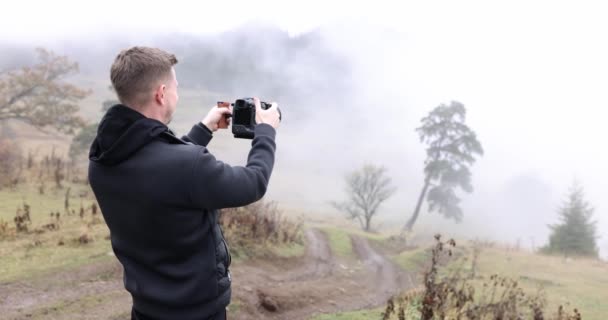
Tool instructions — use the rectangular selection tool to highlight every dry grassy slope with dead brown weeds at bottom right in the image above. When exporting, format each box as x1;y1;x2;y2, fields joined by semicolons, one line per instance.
383;235;608;320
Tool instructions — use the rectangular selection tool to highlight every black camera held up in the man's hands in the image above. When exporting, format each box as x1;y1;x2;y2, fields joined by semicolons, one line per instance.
218;98;281;139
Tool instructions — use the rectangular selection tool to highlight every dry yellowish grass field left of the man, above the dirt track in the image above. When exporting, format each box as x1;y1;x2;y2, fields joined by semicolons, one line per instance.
0;184;114;282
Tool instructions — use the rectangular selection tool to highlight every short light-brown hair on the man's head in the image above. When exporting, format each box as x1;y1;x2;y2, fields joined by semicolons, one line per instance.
110;47;177;105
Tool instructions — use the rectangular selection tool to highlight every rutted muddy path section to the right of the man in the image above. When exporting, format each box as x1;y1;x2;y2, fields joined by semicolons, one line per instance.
233;230;414;320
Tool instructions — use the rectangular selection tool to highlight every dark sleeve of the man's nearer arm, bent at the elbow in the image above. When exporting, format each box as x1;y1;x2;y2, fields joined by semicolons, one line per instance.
190;124;276;209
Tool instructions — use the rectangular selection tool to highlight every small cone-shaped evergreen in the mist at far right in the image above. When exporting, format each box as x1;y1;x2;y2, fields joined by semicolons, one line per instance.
543;183;598;257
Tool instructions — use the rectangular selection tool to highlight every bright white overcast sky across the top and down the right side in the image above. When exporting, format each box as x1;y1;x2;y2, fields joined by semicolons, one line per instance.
0;0;608;255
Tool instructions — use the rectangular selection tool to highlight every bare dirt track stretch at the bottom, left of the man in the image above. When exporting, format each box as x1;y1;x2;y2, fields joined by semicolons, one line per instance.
0;260;131;320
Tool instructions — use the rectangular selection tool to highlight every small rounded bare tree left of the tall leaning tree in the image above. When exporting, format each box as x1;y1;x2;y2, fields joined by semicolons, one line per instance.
332;165;396;231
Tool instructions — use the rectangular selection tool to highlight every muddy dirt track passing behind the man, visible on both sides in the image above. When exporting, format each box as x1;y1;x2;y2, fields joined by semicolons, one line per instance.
0;229;413;320
